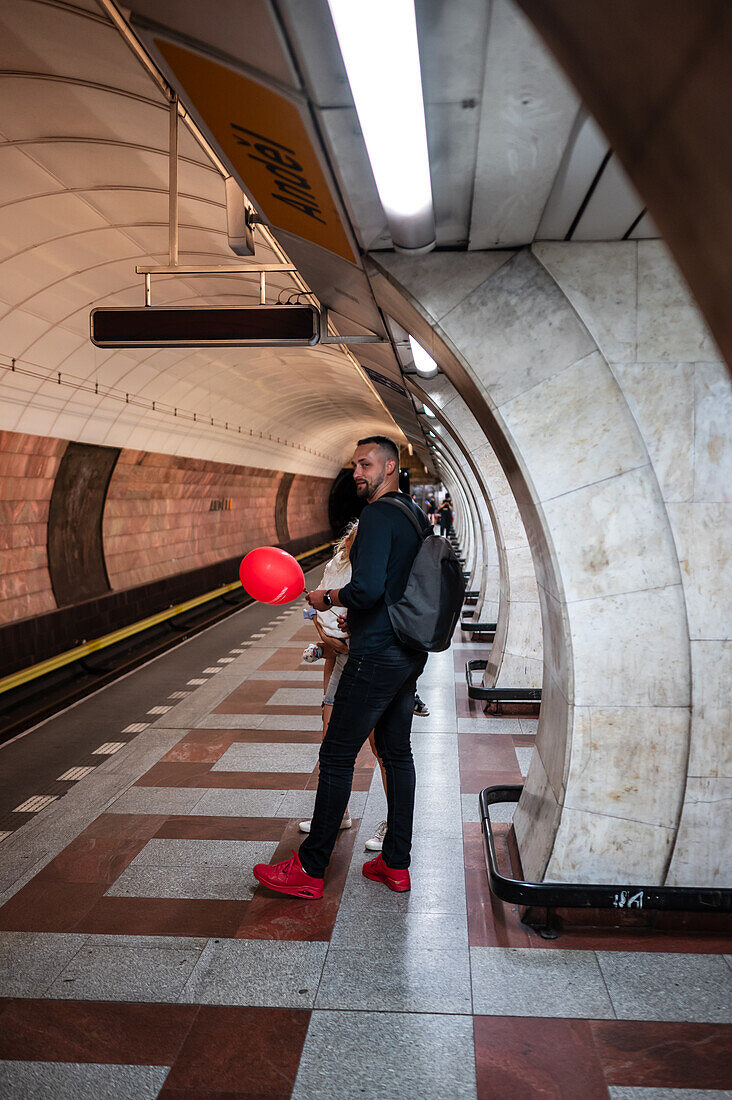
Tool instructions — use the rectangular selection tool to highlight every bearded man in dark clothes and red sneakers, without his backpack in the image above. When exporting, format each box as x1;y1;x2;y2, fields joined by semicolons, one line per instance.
254;436;430;898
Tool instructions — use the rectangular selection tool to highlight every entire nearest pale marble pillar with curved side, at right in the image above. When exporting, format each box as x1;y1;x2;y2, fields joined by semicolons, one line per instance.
372;241;732;886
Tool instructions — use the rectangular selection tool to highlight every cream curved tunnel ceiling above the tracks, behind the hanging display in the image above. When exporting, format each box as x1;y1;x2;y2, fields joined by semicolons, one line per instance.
0;0;405;474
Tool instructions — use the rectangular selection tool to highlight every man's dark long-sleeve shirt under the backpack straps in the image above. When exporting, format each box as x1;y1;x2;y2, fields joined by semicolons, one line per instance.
340;493;431;656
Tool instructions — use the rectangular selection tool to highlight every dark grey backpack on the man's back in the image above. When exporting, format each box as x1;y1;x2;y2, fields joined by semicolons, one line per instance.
382;496;466;653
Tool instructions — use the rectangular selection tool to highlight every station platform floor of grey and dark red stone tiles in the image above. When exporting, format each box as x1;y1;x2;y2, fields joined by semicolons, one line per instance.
0;589;732;1100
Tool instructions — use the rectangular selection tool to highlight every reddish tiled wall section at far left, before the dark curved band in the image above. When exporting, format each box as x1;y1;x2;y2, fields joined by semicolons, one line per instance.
0;431;66;623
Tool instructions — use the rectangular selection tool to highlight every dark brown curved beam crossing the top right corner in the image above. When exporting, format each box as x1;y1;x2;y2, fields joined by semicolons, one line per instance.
517;0;732;367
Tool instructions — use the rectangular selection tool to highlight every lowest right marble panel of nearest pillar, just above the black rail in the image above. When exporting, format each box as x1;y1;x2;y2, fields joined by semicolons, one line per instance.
666;777;732;890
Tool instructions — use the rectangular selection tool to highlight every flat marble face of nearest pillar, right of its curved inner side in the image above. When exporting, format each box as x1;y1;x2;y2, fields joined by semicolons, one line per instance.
535;234;732;884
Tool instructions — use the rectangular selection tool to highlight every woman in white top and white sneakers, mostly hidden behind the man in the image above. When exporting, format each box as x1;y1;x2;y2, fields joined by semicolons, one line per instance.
299;519;386;851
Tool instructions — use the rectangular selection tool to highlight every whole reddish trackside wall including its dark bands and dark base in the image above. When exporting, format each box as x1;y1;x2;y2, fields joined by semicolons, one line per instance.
0;431;331;673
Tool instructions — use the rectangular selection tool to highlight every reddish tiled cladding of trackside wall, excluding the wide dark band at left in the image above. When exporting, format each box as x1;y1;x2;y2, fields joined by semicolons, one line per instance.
0;431;330;629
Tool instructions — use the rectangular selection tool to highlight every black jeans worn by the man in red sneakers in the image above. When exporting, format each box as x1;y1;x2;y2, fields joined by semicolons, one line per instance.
299;646;427;878
